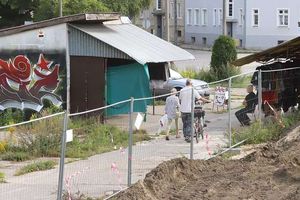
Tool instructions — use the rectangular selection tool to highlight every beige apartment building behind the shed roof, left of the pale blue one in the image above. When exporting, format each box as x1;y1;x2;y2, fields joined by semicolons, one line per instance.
133;0;185;44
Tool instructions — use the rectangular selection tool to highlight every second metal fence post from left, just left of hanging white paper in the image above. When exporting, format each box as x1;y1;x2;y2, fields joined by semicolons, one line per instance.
127;97;134;187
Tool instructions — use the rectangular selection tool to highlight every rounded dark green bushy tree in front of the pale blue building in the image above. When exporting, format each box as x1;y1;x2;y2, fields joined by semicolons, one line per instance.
210;35;238;80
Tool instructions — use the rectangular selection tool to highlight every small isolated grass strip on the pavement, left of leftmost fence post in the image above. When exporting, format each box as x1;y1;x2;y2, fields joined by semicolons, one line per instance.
15;160;57;176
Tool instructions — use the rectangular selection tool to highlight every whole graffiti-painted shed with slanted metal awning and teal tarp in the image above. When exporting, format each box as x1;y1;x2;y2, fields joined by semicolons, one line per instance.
0;13;194;113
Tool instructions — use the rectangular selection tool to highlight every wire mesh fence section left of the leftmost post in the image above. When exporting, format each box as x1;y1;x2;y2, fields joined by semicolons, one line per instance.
0;112;63;200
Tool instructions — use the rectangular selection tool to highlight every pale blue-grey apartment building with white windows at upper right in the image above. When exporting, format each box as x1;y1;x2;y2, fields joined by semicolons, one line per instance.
185;0;300;49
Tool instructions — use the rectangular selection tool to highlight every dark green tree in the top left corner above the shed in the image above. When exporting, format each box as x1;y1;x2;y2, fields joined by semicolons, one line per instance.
0;0;39;28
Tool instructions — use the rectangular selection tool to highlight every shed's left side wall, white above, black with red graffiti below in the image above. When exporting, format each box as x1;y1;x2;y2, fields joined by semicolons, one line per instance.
0;25;67;112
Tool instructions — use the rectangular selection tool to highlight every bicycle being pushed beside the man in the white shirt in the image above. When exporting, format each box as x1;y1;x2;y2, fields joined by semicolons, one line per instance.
194;104;205;143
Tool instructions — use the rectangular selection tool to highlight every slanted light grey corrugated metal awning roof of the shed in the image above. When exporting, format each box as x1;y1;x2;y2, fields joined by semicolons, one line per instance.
73;24;195;64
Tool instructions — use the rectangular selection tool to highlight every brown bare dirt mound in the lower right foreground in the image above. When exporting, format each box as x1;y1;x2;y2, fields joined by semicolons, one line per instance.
115;129;300;200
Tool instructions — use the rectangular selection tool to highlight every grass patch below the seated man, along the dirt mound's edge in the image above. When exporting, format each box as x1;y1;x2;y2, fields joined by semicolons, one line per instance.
232;111;300;144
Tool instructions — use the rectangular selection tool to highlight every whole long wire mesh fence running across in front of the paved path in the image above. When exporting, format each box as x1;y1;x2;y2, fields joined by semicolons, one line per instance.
0;68;300;199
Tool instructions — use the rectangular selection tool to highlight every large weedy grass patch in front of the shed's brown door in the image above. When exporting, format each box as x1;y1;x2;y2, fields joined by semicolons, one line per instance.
66;119;150;158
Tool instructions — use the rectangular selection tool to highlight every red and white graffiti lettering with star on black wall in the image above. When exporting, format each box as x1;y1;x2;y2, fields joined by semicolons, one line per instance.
0;54;62;111
